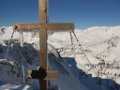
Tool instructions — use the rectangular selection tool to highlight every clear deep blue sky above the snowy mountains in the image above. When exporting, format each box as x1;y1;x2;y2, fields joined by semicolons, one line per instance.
0;0;120;28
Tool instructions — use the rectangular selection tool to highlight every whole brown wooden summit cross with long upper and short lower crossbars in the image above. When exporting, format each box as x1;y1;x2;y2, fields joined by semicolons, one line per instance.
13;0;74;90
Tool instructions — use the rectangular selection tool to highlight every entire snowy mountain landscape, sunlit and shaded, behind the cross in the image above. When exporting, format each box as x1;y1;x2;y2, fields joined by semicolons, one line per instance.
0;26;120;90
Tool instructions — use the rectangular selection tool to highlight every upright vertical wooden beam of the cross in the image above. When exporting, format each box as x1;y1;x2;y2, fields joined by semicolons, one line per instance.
39;0;48;90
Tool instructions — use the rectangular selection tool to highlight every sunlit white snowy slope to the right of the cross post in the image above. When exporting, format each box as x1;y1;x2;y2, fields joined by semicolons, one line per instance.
49;26;120;83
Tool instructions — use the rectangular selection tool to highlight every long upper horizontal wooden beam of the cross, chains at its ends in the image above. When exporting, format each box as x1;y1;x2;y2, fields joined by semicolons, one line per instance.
13;23;74;31
